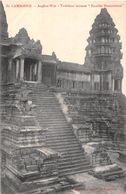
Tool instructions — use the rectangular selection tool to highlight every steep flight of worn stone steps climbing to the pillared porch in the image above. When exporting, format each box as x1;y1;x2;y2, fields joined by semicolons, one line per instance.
24;83;91;177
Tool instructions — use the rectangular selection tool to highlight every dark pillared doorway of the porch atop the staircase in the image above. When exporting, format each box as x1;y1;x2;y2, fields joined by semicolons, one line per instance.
24;58;38;81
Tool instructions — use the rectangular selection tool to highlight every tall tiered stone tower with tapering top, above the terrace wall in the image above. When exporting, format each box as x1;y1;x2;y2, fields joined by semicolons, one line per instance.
85;8;123;92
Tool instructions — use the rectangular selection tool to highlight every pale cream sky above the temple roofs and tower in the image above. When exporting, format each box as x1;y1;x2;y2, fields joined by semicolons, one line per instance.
3;0;126;94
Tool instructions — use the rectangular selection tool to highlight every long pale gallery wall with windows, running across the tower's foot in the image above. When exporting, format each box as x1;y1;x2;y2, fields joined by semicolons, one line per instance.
56;69;122;93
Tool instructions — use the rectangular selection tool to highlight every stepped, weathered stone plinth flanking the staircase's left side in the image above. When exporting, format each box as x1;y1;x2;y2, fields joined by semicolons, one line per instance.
2;83;58;185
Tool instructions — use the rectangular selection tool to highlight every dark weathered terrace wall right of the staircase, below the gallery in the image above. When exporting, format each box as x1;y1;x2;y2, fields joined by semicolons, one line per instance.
61;92;124;144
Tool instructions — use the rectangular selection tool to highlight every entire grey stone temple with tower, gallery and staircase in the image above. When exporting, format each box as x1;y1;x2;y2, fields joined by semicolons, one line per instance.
0;2;126;194
